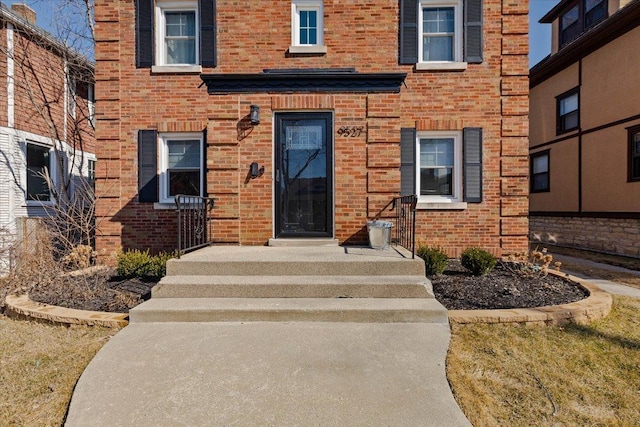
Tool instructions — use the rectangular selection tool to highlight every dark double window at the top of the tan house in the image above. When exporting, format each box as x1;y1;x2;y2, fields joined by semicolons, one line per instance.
560;0;607;47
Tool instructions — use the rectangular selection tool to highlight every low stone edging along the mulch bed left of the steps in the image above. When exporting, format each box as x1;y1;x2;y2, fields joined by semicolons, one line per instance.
5;294;129;328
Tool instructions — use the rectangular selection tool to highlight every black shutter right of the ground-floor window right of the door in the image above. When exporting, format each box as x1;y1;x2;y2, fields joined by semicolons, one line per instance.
462;128;482;203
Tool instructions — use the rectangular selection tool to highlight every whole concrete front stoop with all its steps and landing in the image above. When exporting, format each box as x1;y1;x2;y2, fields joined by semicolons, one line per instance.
130;245;448;324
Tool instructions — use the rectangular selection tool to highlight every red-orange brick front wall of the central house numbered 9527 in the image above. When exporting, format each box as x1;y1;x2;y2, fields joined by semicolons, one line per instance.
96;0;528;255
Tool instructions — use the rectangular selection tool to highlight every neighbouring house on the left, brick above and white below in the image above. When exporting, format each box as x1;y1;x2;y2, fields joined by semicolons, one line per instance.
0;4;96;268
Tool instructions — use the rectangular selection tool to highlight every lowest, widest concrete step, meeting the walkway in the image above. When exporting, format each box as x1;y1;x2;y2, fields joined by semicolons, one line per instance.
129;298;448;323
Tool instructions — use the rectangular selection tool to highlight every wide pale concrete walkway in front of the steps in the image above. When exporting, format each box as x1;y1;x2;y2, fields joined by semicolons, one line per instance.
66;322;470;427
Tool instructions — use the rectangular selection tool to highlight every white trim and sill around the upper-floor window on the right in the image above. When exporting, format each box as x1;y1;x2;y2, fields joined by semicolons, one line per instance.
416;0;467;70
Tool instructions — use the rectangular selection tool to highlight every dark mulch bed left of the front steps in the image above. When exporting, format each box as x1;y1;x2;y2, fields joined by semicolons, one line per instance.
29;268;157;313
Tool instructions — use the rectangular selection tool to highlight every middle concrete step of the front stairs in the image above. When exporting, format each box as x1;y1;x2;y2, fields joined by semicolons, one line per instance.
151;276;434;298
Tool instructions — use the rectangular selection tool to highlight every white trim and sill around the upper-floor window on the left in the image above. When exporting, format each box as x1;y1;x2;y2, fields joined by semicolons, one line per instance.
151;1;201;67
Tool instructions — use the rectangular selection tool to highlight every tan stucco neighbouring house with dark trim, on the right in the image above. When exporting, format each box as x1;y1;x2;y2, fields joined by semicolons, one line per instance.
530;0;640;257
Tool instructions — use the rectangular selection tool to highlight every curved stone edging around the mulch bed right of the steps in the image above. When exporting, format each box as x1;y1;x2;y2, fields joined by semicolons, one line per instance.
449;271;612;324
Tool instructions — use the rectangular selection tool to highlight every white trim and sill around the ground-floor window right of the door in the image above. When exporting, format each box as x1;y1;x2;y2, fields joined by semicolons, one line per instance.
415;131;467;209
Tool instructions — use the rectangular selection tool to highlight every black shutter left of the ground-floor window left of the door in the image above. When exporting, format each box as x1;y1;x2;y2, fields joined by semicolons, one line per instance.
138;130;158;202
